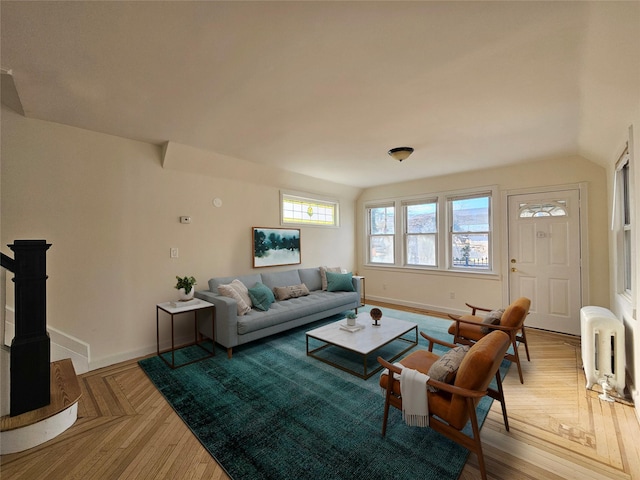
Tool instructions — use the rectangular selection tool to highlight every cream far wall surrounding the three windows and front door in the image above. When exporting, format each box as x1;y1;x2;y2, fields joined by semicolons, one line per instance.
357;157;609;312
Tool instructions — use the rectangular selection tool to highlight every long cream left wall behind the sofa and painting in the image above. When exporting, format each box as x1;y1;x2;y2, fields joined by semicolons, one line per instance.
0;108;359;369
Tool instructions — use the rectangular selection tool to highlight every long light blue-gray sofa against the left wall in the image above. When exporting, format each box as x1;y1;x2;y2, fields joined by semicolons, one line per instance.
195;268;361;358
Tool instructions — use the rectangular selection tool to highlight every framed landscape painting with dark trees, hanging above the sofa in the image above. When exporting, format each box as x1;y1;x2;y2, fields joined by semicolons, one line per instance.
252;227;302;268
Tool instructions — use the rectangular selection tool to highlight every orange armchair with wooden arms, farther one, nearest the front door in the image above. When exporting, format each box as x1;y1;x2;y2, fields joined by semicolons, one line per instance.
449;297;531;383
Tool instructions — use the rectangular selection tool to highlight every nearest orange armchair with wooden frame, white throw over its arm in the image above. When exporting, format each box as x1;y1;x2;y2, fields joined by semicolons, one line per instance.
378;331;510;480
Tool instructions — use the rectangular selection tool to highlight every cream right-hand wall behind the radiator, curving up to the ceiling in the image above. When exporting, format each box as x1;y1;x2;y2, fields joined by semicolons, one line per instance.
578;2;640;418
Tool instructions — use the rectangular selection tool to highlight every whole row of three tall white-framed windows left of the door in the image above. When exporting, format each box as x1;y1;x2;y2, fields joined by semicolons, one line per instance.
365;187;495;274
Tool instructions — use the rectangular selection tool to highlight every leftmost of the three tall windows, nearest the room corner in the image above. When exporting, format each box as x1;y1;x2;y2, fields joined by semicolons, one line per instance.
367;204;396;265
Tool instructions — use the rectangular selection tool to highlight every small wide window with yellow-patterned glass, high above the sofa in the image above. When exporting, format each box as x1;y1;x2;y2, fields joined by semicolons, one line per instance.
280;192;339;227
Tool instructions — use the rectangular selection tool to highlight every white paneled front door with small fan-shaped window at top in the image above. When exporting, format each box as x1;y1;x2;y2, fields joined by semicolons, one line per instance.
508;190;582;335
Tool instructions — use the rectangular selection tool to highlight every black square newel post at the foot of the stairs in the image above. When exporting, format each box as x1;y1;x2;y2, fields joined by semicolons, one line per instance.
8;240;51;417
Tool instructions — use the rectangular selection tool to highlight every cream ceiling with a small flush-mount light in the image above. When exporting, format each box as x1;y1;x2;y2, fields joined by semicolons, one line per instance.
0;0;640;187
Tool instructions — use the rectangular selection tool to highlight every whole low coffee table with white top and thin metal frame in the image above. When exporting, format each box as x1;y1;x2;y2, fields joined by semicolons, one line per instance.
306;313;418;380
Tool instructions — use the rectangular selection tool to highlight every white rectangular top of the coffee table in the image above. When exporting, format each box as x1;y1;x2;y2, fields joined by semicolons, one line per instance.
306;312;418;355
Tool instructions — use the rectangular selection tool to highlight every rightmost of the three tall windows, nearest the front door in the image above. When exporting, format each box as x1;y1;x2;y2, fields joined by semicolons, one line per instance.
448;194;491;270
